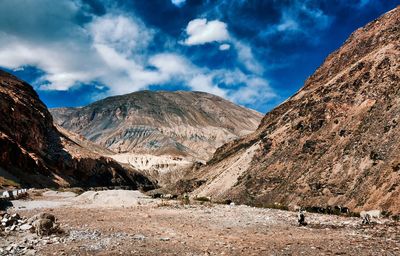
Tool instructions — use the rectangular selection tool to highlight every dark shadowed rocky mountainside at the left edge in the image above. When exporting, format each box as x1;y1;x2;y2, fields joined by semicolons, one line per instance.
0;70;154;189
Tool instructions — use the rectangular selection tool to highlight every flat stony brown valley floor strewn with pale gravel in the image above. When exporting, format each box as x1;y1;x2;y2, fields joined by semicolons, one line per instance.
0;191;400;255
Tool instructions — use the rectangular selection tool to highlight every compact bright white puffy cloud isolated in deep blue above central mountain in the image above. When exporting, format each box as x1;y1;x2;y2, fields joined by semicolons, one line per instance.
184;19;229;45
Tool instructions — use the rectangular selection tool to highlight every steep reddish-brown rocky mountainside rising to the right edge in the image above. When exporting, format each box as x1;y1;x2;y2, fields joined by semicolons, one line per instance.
184;7;400;213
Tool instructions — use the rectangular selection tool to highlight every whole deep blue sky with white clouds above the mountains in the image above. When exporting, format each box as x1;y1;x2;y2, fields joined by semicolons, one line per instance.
0;0;400;113
